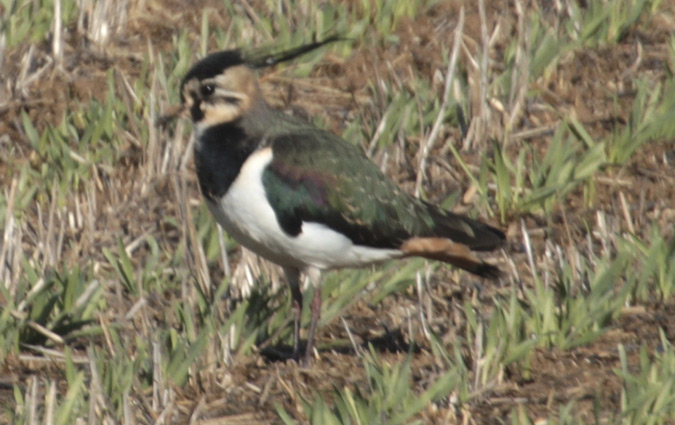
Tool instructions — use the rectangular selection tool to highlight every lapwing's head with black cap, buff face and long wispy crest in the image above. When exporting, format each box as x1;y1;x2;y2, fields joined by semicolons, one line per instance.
181;37;338;127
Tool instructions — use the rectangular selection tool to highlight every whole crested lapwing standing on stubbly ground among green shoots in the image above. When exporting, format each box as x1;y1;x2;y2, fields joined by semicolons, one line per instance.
181;40;505;365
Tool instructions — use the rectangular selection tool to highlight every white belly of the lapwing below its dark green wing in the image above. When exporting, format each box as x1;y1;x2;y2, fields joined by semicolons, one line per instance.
208;148;402;269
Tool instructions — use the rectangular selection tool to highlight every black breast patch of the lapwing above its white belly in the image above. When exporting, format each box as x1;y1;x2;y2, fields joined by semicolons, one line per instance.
194;123;257;201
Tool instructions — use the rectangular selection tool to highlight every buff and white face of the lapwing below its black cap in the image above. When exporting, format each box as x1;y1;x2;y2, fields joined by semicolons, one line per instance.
183;65;260;128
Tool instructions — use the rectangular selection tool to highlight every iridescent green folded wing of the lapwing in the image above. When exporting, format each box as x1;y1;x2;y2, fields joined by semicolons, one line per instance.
263;128;503;249
